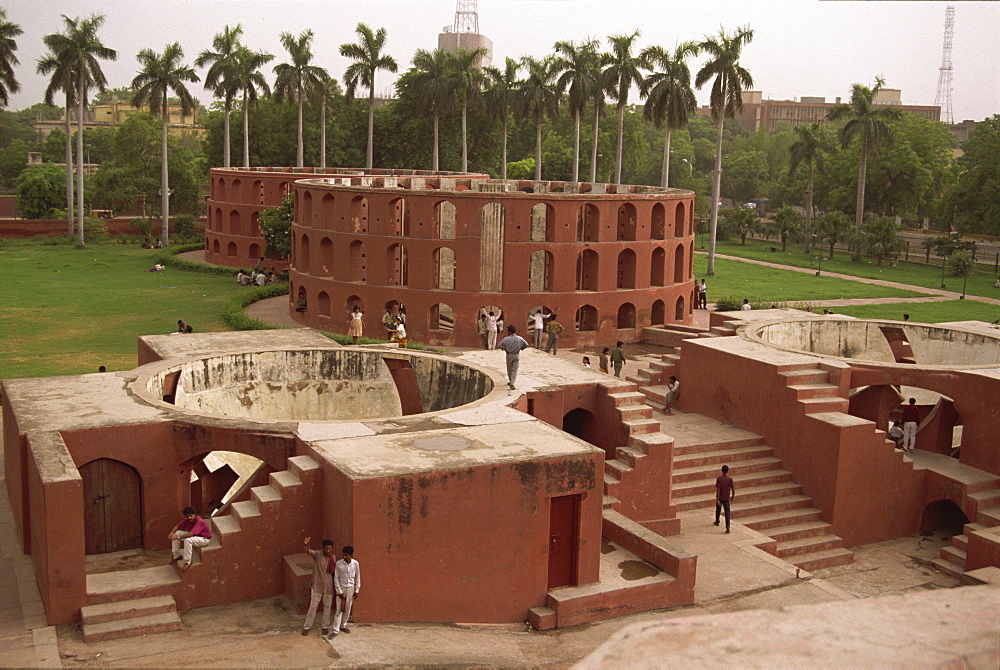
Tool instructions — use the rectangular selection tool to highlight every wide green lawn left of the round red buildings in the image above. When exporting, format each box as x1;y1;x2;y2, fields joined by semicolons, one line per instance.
0;243;240;379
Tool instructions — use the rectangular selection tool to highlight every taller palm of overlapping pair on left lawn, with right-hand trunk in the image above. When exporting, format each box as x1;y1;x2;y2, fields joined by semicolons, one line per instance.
39;14;118;247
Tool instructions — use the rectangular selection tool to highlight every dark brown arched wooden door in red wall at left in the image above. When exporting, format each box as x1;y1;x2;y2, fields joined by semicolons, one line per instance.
80;458;142;554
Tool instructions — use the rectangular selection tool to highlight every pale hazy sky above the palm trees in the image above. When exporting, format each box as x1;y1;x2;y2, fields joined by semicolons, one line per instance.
7;0;1000;121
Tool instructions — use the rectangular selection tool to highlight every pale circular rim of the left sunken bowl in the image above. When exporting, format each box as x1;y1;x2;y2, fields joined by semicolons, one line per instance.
128;345;510;427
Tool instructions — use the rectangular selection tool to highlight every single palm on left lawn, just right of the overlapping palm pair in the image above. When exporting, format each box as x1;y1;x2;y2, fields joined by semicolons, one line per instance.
132;42;198;246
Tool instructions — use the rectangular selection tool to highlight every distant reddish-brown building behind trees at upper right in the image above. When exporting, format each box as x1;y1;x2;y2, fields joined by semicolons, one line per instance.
698;88;941;132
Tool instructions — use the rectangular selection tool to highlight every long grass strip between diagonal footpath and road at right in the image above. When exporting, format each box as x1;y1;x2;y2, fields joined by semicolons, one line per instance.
695;236;1000;298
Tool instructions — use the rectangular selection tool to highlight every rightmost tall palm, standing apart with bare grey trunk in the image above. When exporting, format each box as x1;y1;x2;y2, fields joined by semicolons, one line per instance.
826;77;902;236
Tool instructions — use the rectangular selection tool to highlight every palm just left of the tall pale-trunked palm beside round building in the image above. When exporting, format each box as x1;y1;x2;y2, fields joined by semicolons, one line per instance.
640;42;698;188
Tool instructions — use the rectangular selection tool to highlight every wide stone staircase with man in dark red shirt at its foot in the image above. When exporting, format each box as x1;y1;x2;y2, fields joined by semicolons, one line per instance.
672;437;854;571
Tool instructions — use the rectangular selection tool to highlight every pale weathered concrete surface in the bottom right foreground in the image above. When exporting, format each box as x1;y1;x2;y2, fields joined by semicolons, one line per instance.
575;586;1000;668
